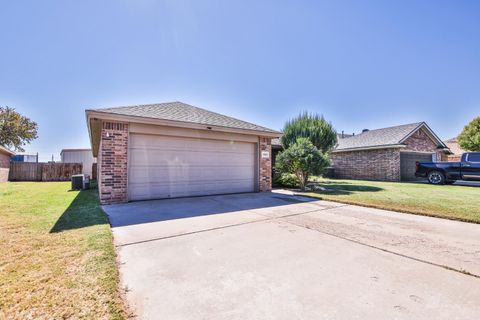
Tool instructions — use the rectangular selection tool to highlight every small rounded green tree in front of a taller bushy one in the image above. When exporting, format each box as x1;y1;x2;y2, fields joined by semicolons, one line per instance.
275;137;330;191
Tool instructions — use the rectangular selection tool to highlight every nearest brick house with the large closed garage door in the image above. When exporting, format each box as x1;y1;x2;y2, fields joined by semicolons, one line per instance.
86;102;280;204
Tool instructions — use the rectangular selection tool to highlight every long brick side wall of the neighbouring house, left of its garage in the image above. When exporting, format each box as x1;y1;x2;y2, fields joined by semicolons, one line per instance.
330;148;400;181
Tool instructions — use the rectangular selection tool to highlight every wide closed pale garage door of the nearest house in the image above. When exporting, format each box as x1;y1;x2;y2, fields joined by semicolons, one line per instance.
128;134;256;200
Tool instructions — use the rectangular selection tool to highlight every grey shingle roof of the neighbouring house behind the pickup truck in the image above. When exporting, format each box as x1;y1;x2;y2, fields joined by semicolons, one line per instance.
334;122;446;152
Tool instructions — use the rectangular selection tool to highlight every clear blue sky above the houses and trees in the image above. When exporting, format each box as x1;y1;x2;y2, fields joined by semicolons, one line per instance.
0;0;480;160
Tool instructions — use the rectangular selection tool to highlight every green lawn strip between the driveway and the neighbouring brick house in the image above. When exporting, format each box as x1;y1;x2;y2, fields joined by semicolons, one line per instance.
307;179;480;223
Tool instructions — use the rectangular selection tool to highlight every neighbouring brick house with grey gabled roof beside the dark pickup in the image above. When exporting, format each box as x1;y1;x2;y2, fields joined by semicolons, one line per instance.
330;122;451;181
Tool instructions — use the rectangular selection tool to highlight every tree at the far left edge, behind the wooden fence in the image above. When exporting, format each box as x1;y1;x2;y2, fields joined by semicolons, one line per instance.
0;107;38;151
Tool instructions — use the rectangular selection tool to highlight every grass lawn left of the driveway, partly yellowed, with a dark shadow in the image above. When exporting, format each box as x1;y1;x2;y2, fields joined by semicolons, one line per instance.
0;182;127;319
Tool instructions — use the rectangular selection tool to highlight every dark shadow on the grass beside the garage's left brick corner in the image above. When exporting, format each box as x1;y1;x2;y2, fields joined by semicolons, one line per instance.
50;189;108;233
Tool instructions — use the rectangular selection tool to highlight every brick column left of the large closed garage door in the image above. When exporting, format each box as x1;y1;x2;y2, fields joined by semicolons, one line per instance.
98;121;128;204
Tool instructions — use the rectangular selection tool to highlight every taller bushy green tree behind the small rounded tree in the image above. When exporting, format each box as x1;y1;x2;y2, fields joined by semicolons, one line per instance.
281;112;337;152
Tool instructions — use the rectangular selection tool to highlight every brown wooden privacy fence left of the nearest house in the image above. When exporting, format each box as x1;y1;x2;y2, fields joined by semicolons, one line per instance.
8;161;83;181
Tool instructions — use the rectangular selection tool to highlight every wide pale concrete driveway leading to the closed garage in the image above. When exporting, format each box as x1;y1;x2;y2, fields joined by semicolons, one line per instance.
104;193;480;320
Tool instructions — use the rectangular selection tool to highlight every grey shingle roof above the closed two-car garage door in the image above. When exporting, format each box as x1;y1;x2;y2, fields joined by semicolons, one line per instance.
87;101;279;133
